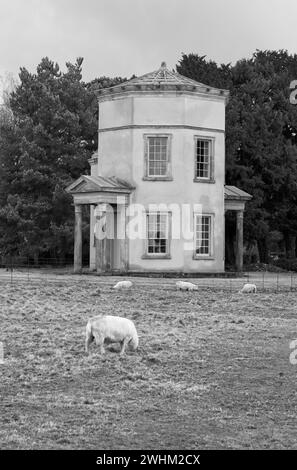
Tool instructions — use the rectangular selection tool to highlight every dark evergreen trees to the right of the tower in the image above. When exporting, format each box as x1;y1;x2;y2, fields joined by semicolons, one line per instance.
177;51;297;262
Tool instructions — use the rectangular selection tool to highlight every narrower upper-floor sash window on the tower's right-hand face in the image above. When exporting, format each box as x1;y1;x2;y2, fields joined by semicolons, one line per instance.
195;137;214;181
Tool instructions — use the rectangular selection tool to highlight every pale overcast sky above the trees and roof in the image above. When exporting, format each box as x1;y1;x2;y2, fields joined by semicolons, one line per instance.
0;0;297;81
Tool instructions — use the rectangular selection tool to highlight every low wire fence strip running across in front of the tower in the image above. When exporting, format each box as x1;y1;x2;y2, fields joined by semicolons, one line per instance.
0;258;297;293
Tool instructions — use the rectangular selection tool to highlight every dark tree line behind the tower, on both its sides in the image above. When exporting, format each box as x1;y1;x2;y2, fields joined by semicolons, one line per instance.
0;50;297;262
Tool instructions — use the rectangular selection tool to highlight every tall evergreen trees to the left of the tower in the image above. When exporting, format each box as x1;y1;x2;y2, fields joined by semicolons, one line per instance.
0;58;125;259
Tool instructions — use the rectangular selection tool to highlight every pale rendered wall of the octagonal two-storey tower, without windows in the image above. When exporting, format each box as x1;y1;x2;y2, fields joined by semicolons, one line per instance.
98;94;225;272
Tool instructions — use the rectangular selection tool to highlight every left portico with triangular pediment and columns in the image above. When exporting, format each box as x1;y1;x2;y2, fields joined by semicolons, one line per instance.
67;175;134;273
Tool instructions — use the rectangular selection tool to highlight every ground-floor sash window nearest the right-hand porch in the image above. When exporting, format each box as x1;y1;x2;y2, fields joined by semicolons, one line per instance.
194;214;213;258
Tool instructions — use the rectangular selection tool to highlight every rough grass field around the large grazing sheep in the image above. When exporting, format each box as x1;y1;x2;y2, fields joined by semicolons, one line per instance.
0;277;297;450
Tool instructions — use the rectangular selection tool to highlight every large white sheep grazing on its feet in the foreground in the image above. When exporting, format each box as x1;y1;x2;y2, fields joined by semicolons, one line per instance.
86;315;138;356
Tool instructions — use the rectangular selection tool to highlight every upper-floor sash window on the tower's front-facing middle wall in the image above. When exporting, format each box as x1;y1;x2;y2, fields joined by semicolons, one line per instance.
144;134;172;180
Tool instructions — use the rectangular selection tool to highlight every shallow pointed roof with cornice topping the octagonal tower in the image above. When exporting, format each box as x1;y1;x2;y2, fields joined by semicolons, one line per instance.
97;62;229;97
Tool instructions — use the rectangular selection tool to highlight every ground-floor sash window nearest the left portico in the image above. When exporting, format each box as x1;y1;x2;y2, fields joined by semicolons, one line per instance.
146;212;169;256
